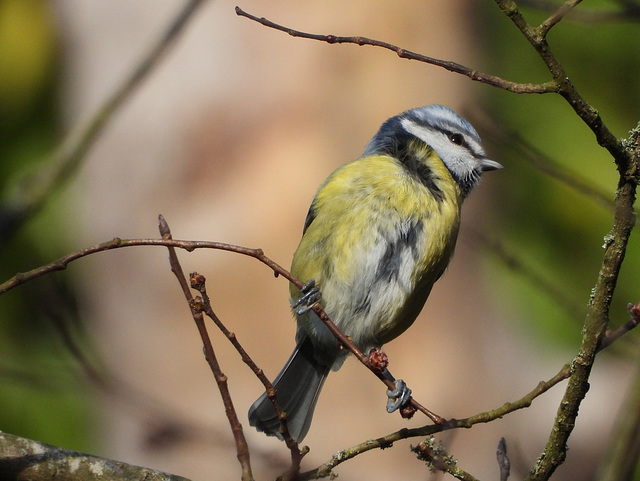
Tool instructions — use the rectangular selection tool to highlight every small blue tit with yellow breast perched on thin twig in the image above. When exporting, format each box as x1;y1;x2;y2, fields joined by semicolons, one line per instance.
249;105;502;442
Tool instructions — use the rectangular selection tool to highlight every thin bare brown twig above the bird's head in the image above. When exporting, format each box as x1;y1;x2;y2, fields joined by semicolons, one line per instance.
236;7;558;94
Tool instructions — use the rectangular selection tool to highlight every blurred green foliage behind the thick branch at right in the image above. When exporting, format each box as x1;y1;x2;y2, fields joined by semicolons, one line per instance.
479;2;640;347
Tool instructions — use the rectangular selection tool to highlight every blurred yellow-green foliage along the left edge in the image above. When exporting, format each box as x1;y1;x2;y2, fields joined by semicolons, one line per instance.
0;0;88;449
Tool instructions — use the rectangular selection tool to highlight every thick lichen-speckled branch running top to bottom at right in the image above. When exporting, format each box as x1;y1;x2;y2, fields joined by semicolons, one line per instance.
482;0;640;480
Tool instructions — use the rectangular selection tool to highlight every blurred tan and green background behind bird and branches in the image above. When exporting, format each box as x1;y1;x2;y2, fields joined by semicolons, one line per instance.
0;0;640;480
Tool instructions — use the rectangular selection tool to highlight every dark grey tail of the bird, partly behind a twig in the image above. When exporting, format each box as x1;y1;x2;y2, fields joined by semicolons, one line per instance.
249;337;330;442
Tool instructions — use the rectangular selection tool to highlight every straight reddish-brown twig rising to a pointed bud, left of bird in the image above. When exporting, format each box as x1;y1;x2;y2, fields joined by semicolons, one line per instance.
158;215;253;481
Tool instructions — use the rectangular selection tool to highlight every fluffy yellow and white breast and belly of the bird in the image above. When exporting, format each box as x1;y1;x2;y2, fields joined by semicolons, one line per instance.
292;157;460;349
